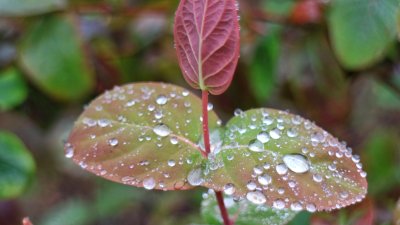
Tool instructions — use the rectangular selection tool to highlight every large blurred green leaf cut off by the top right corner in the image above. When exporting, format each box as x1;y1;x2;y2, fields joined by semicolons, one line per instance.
328;0;400;69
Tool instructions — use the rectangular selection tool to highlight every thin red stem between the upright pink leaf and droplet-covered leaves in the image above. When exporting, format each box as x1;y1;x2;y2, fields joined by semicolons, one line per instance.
201;90;233;225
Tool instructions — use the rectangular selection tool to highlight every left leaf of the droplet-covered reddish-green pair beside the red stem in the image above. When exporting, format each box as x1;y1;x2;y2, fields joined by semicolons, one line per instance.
66;83;218;190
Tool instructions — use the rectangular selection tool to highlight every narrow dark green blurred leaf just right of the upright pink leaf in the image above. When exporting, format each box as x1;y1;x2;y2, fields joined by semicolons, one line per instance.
249;27;280;103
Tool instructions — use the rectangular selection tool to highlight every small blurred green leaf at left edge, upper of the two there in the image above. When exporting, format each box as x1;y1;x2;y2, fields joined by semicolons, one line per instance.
0;68;27;111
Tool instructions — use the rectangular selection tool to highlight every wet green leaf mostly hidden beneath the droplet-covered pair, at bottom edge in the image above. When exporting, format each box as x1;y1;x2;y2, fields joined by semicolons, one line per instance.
201;191;296;225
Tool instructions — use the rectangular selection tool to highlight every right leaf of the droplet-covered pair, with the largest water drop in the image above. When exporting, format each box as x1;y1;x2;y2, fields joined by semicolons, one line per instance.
203;109;367;212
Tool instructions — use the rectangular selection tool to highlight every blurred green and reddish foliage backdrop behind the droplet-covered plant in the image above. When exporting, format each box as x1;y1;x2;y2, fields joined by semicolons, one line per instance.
0;0;400;225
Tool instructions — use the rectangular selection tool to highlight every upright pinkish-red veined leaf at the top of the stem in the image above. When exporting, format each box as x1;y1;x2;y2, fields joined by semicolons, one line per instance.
174;0;240;95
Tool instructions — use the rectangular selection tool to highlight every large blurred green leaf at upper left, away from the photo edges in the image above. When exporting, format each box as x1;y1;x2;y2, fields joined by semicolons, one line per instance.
19;15;94;101
